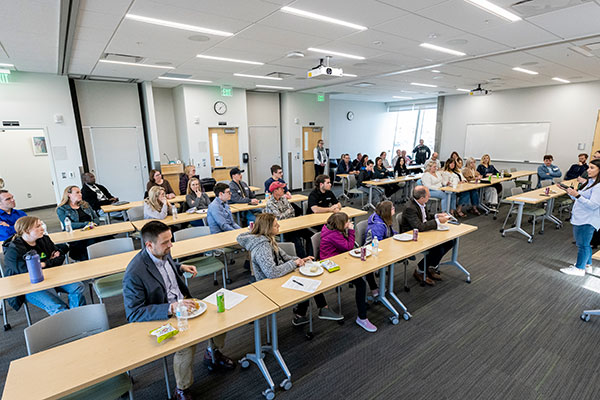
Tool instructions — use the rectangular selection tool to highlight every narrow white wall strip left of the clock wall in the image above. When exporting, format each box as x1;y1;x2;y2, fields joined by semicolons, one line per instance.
152;88;183;163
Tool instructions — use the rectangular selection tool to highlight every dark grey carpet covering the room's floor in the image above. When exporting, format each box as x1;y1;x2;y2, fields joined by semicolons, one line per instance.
0;195;600;399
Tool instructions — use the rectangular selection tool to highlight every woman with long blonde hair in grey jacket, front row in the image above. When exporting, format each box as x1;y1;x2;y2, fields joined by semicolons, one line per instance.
237;213;344;326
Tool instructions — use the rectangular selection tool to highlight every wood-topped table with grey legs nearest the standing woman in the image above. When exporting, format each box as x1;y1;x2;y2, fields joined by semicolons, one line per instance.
501;179;577;243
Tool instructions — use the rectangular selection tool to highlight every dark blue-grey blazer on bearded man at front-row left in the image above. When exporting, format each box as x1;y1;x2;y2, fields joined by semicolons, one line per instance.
123;248;192;322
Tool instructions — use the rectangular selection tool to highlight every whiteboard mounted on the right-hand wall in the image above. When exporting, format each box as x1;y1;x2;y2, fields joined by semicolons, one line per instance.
465;122;550;162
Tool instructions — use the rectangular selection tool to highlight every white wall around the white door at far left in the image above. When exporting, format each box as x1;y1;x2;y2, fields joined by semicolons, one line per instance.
0;72;81;207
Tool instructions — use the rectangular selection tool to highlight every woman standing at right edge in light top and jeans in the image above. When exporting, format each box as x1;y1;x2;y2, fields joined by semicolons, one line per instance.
560;160;600;276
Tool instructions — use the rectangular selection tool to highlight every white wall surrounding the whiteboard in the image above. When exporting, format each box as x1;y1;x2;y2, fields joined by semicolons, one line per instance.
440;82;600;174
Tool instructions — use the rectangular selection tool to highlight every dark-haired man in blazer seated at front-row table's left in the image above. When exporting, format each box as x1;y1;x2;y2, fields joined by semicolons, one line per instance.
123;221;235;399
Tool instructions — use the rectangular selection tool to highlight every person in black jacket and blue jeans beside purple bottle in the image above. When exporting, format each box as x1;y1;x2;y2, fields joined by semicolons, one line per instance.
2;217;85;315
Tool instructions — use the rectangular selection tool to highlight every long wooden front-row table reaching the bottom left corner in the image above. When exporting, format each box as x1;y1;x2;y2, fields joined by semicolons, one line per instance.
2;285;286;400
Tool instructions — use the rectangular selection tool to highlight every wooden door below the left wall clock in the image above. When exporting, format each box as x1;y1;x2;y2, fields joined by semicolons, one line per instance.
208;128;240;182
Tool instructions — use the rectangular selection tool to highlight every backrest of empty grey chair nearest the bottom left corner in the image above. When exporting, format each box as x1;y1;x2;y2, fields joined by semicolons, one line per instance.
25;304;109;355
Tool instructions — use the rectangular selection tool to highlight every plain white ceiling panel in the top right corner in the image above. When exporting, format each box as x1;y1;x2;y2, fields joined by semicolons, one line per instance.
528;2;600;39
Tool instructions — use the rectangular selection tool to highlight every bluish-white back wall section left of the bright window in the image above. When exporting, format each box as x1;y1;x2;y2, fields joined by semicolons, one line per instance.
329;100;396;162
